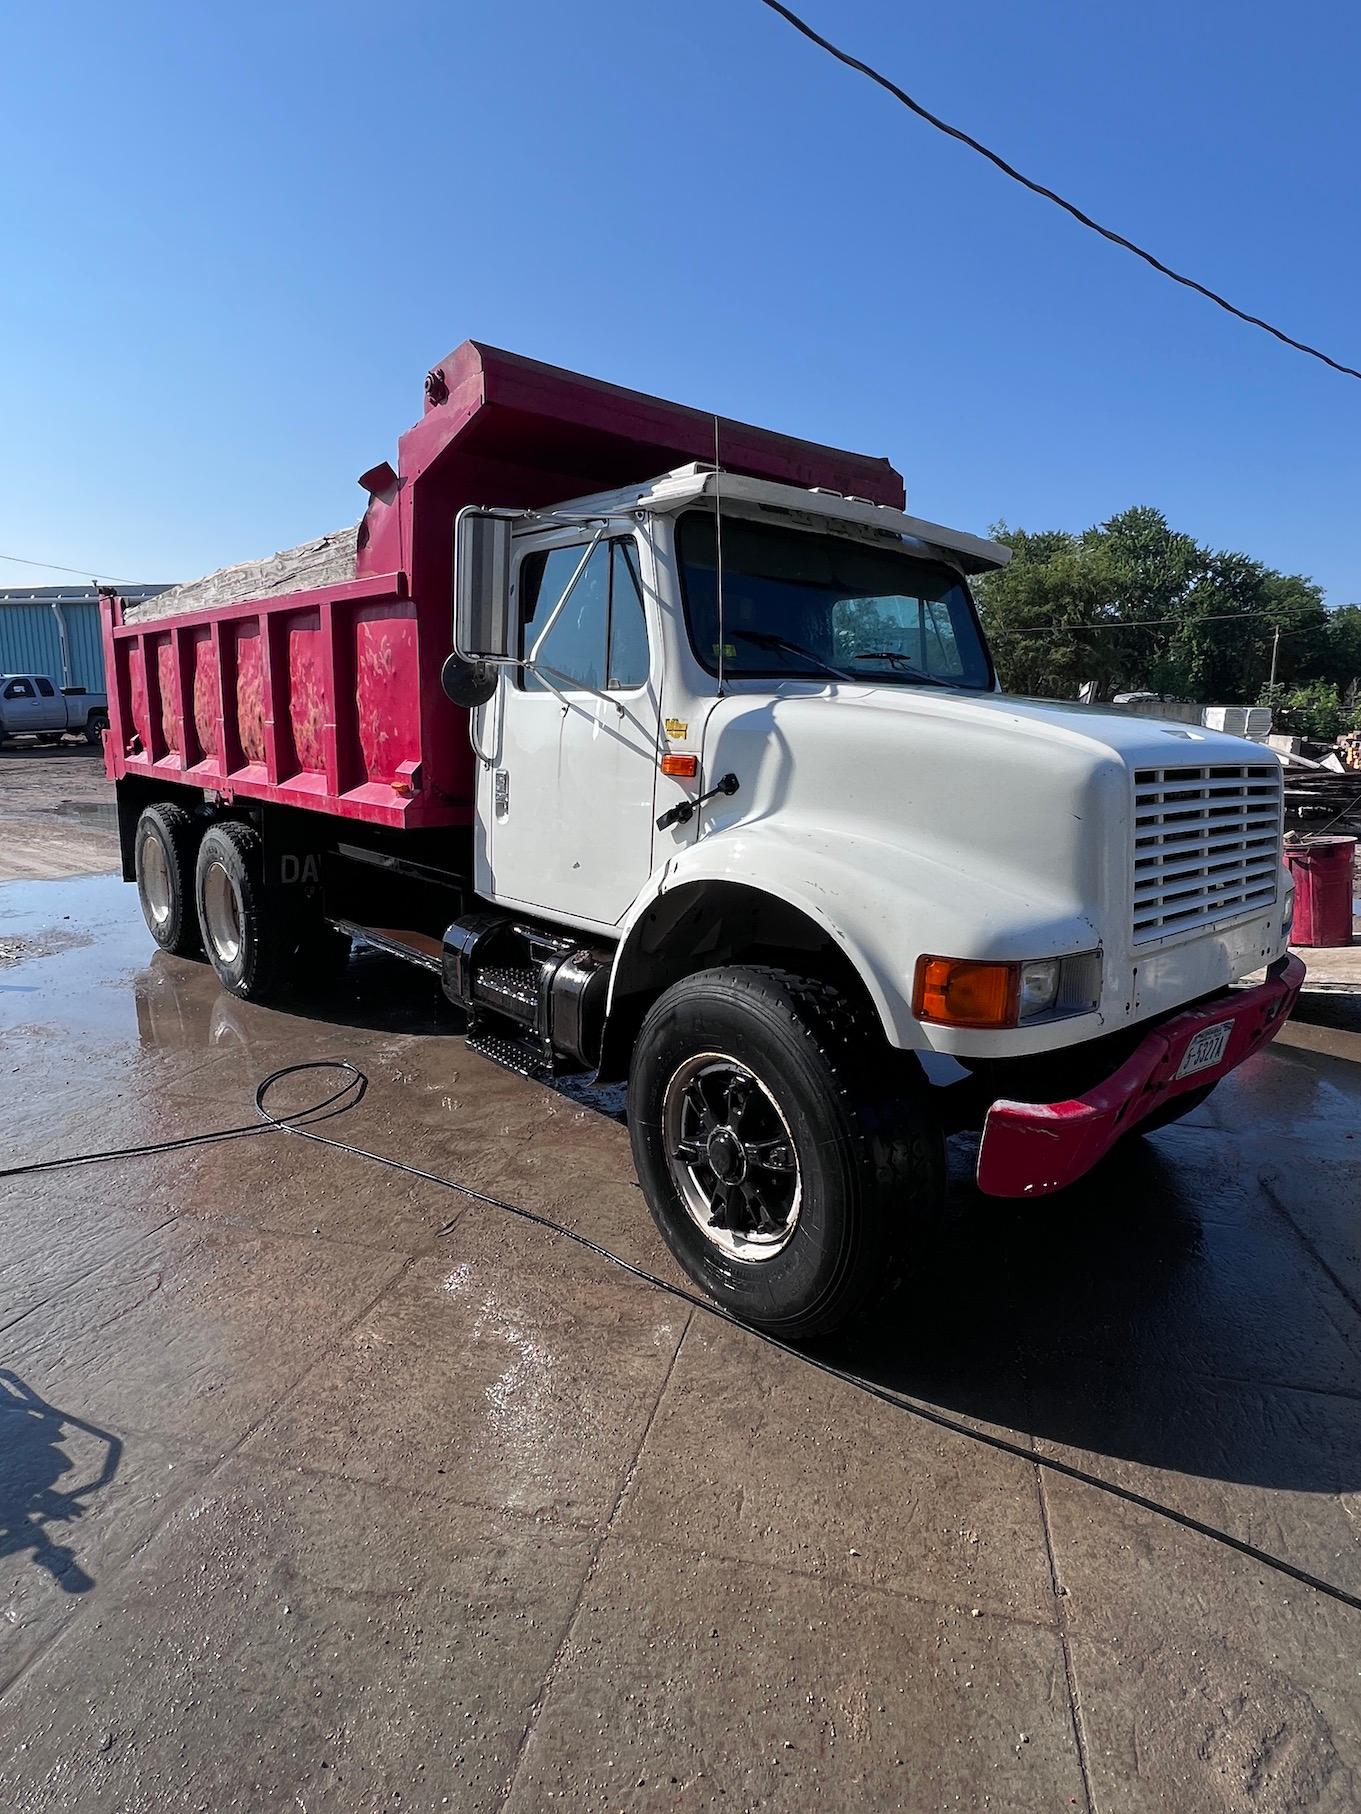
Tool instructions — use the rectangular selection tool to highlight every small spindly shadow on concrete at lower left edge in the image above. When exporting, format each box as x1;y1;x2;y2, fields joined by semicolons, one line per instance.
0;1368;123;1593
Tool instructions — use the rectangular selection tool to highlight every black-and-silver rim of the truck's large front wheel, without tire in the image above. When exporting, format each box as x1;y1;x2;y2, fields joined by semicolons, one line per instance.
662;1052;804;1263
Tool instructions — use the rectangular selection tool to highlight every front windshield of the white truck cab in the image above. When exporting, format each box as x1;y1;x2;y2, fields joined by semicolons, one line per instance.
677;510;993;689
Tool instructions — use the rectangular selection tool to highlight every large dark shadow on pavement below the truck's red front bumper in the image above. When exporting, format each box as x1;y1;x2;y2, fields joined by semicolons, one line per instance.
838;1136;1361;1493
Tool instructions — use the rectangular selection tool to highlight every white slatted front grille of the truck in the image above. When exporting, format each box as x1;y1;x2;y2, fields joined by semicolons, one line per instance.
1134;762;1281;945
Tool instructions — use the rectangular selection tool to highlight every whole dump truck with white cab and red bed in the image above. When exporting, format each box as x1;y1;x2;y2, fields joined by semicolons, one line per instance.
105;341;1303;1339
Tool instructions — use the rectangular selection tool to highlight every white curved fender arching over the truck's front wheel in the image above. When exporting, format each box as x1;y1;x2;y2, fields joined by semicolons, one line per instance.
610;818;1100;1052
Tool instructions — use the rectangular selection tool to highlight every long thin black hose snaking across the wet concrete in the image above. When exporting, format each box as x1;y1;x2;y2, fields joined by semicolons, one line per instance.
0;1058;1361;1613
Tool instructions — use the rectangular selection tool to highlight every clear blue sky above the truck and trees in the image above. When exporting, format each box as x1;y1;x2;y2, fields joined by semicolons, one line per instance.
0;0;1361;602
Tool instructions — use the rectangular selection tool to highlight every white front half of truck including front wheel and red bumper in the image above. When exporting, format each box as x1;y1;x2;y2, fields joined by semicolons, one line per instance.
450;466;1303;1333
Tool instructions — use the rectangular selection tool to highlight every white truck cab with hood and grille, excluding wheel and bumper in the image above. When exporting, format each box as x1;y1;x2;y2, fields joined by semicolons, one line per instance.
461;466;1290;1058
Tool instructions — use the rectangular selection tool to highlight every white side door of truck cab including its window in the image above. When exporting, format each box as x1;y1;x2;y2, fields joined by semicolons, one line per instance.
479;533;659;927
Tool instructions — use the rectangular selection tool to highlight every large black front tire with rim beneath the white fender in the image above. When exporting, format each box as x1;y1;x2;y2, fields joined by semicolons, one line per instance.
628;967;945;1341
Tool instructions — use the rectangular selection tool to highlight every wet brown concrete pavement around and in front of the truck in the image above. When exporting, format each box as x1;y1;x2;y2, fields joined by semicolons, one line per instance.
0;830;1361;1814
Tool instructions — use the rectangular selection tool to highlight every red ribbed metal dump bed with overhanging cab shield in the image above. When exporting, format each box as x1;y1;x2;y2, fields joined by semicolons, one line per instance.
103;341;904;827
